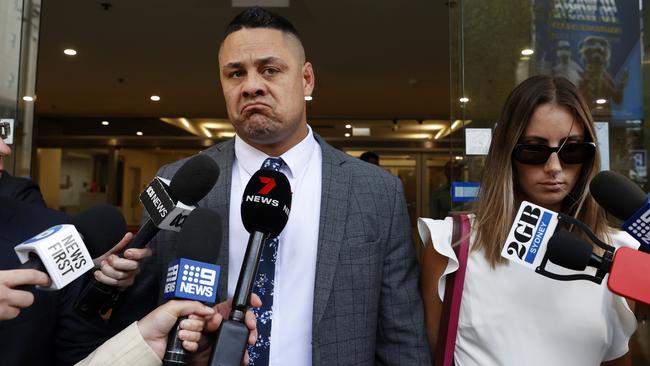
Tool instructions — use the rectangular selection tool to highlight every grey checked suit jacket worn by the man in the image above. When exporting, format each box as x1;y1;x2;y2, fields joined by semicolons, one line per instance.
116;135;430;365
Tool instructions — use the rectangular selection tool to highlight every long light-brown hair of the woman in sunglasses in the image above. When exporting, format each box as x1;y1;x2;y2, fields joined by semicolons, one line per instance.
472;75;607;267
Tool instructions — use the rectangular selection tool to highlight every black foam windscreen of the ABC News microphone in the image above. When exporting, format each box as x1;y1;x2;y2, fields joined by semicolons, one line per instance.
169;154;219;206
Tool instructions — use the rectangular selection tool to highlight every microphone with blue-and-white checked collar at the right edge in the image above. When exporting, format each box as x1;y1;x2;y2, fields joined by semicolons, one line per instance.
589;171;650;253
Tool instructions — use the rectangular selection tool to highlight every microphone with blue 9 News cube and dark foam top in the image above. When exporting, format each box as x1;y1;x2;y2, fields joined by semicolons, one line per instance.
162;207;222;365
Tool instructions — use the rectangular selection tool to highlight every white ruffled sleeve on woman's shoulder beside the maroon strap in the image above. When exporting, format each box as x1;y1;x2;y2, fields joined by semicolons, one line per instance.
418;217;458;301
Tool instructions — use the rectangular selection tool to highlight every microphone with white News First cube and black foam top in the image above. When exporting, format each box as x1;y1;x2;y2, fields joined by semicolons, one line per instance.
14;204;126;290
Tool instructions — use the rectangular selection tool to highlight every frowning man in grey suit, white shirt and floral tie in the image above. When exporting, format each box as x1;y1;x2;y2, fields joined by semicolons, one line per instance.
97;8;430;365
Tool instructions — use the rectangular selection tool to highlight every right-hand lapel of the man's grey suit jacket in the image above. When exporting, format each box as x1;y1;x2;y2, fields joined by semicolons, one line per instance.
312;134;350;332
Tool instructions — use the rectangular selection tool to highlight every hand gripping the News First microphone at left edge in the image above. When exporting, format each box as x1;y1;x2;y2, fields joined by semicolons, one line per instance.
0;269;50;320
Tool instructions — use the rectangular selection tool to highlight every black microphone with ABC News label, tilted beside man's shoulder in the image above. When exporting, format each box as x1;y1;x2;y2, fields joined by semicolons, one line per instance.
74;154;219;319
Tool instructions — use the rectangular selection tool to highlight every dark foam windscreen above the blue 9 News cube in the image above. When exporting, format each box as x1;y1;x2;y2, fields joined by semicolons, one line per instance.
177;207;223;263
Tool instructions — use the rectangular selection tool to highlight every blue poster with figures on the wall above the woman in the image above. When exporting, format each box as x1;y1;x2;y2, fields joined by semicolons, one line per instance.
534;0;643;123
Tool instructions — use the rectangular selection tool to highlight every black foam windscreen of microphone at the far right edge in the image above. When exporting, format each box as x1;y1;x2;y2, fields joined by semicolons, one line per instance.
589;170;646;221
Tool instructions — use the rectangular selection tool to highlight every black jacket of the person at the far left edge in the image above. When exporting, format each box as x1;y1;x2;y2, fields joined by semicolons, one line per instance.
0;199;108;366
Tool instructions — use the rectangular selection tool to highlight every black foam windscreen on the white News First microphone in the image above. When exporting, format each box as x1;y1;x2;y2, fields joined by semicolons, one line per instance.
72;204;126;258
